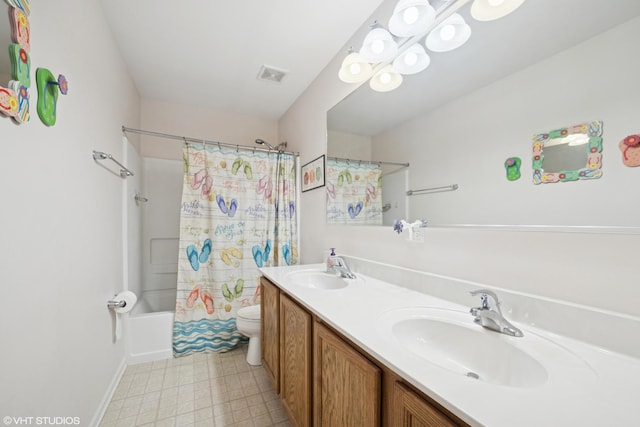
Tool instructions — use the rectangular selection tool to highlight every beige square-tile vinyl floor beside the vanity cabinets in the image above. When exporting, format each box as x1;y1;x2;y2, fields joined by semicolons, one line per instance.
100;345;290;427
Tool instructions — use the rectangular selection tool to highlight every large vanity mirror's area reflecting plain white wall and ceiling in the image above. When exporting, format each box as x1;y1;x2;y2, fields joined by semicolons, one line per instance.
327;0;640;231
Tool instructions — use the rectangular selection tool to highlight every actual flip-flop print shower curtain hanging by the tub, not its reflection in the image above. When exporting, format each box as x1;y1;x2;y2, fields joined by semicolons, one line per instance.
173;143;298;357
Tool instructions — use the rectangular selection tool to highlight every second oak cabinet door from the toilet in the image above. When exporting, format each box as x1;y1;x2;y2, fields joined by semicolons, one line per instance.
280;294;312;426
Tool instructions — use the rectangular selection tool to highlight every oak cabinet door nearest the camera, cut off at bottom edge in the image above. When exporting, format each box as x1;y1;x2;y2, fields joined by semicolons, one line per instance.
393;382;459;427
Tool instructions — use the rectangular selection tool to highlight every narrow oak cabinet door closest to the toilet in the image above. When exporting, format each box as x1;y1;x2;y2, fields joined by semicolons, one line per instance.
260;277;280;393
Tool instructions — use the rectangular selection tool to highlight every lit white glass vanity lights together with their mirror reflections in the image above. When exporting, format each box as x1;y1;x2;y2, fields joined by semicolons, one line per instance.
338;0;525;92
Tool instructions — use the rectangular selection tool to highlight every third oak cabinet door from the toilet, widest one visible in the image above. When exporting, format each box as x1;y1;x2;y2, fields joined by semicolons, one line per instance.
313;323;381;427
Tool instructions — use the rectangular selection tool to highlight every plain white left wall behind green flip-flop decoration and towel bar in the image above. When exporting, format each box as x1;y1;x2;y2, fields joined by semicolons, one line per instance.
0;0;139;425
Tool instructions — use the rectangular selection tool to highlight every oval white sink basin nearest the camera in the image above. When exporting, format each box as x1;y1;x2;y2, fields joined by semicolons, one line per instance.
378;307;589;388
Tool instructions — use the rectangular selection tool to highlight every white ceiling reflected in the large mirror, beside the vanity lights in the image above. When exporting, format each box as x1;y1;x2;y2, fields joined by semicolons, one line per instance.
328;0;640;136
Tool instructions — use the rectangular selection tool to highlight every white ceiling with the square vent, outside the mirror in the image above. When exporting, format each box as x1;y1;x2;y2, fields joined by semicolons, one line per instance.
100;0;382;120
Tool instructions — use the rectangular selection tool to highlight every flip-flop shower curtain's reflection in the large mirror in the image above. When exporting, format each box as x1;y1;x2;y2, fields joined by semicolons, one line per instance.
325;159;382;225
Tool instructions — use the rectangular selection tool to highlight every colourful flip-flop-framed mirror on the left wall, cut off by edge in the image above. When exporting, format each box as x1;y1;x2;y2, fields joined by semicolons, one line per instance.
0;0;31;124
